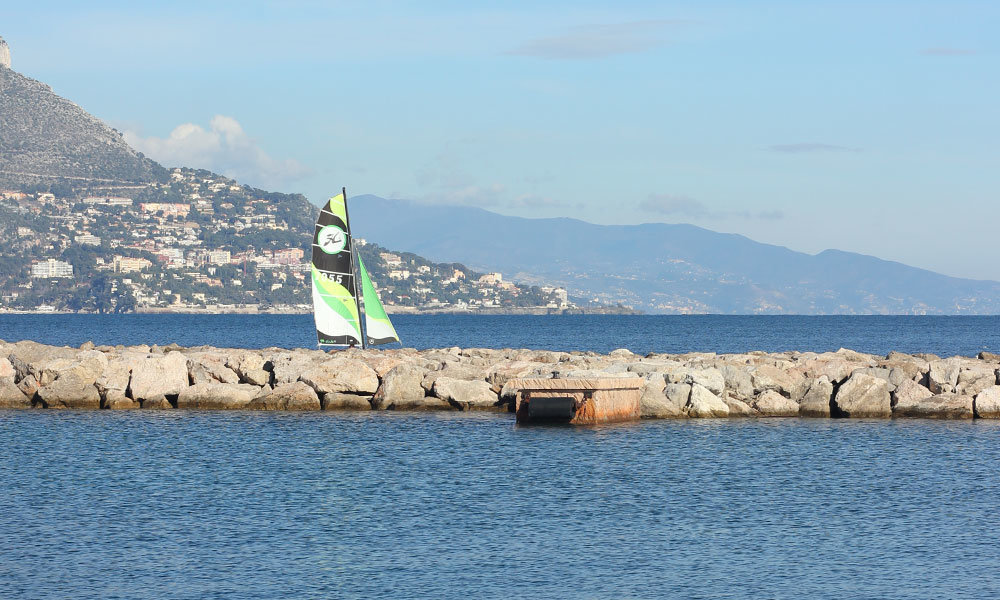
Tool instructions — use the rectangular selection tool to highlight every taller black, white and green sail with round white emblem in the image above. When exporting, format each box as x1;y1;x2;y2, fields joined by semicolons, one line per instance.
312;194;361;346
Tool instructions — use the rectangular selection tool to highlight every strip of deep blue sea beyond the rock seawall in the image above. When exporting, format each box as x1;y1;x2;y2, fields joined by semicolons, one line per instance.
0;314;1000;356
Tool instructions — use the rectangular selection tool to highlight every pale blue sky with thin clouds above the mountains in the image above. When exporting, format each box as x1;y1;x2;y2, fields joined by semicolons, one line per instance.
0;0;1000;280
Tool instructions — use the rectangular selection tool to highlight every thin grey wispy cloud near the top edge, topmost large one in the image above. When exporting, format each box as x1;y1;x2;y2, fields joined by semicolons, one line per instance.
507;19;683;60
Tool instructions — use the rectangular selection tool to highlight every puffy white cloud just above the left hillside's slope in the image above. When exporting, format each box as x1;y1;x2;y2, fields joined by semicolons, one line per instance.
124;115;311;187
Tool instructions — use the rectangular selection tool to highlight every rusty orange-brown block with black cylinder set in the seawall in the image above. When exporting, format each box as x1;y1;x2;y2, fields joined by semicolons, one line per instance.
514;377;642;425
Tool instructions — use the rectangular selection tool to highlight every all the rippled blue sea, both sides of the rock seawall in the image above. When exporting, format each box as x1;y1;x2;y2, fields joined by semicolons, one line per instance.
0;315;1000;599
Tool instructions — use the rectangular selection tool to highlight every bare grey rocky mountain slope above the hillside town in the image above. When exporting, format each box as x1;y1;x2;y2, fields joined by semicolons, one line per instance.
0;65;167;188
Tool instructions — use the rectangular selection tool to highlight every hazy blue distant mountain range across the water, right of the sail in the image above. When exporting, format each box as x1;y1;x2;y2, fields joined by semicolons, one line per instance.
351;196;1000;314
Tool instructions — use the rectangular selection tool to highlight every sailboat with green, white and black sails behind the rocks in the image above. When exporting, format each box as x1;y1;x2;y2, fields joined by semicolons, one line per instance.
312;188;399;348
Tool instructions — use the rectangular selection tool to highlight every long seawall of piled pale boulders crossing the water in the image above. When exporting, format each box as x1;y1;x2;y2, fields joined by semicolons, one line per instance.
0;341;1000;419
